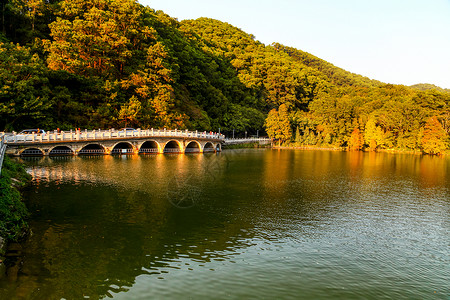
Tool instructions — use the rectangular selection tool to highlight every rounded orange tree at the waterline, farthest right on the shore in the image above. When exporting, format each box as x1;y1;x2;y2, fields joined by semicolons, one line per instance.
421;116;447;154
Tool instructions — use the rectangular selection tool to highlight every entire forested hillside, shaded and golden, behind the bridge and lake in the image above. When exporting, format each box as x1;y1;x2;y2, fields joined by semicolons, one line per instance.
0;0;450;153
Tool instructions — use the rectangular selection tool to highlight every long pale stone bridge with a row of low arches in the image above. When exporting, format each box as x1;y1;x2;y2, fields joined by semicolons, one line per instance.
4;129;225;156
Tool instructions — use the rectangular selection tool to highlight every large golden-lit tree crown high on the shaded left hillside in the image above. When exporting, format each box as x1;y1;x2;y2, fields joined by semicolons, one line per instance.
47;0;156;78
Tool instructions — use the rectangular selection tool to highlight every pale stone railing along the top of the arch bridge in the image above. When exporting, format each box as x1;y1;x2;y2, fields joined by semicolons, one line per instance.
4;128;225;144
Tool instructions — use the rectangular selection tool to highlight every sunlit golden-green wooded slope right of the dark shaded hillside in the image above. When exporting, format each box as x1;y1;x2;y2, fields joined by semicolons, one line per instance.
182;18;450;150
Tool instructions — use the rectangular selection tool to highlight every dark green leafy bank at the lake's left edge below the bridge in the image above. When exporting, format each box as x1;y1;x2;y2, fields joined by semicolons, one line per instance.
0;157;31;241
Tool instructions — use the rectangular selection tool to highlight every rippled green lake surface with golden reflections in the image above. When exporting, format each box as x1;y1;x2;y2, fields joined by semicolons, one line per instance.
0;150;450;299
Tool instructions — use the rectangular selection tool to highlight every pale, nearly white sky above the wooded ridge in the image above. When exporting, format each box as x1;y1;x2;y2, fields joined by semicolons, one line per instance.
138;0;450;89
